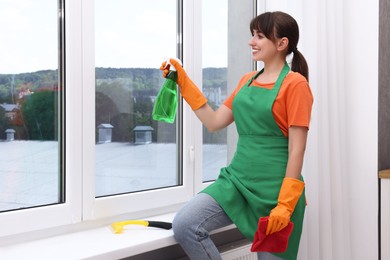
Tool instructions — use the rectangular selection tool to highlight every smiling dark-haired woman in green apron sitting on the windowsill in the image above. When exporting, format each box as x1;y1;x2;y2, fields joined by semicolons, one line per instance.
161;12;313;260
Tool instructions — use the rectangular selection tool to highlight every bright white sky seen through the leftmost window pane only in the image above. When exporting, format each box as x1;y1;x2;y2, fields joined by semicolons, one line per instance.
0;0;58;74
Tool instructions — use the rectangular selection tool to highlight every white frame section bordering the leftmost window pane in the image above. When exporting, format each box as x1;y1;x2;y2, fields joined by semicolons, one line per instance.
0;0;82;238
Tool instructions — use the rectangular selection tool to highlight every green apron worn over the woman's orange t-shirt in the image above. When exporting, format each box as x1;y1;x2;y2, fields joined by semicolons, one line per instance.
202;63;306;260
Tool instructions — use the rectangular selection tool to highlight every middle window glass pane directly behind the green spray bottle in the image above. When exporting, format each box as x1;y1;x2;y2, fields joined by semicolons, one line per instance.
95;0;180;197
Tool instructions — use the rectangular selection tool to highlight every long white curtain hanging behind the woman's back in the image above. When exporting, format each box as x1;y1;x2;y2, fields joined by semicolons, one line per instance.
259;0;378;260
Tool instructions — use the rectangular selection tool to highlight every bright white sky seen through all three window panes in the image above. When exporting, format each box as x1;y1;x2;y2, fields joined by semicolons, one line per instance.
0;0;228;74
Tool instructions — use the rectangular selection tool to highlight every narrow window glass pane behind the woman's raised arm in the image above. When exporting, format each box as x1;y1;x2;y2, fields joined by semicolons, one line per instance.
202;0;228;181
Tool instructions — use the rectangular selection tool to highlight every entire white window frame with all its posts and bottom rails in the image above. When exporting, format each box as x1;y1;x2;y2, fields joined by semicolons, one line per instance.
0;0;253;244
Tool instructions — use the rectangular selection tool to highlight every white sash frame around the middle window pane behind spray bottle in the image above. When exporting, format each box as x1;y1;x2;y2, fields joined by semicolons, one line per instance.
82;0;197;220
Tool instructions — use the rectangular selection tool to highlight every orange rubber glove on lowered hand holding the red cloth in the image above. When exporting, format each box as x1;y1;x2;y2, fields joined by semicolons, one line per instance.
265;177;305;235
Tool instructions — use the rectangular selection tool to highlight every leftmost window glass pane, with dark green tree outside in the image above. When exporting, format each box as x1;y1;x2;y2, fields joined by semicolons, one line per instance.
0;0;62;211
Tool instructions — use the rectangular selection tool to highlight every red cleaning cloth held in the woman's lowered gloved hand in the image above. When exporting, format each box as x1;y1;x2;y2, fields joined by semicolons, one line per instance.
251;217;294;253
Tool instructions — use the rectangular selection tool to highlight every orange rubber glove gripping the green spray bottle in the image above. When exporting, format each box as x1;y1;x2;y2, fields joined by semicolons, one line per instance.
160;59;207;110
